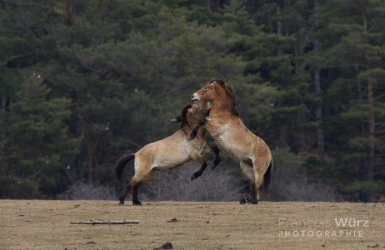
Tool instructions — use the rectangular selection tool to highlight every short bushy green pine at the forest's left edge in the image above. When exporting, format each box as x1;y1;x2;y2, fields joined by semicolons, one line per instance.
0;75;79;198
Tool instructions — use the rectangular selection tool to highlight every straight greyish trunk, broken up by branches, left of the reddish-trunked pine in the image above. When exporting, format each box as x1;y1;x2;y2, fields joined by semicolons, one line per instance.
313;0;325;161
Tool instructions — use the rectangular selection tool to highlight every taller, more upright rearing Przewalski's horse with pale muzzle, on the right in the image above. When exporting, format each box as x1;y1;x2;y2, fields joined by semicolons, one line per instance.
188;79;273;204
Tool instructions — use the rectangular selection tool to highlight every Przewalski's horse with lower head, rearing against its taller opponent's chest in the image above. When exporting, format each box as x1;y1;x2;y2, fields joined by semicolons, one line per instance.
115;102;220;205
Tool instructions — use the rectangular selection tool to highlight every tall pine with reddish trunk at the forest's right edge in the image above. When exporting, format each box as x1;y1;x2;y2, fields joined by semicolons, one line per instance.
323;0;385;201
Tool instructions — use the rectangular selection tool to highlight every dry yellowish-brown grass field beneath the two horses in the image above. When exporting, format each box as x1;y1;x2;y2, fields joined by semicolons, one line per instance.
0;200;385;250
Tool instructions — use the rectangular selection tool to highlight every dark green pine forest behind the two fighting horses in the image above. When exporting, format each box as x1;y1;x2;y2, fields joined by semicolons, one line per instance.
0;0;385;201
